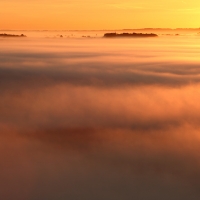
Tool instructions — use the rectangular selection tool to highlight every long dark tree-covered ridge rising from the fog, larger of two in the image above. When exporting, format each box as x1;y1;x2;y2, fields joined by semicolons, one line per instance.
104;33;158;38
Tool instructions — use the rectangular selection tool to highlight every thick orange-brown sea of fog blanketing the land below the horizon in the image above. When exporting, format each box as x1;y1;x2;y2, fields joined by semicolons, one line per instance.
0;32;200;200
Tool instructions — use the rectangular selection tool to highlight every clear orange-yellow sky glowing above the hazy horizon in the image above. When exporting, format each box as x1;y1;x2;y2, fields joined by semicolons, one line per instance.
0;0;200;30
